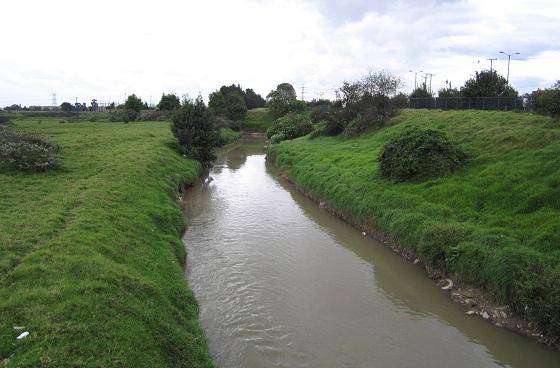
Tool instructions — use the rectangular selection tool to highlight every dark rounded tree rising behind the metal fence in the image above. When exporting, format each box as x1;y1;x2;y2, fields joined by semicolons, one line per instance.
460;70;518;97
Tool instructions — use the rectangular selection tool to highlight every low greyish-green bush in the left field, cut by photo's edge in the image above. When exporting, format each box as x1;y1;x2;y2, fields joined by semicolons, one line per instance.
0;128;58;171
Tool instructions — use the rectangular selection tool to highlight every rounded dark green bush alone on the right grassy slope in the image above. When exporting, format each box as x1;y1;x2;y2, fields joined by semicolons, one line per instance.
378;129;465;181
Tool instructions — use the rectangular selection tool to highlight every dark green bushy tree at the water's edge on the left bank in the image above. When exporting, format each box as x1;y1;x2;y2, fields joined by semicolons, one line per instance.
171;95;217;167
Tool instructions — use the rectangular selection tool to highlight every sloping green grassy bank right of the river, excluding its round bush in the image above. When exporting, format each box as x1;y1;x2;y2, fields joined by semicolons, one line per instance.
269;110;560;336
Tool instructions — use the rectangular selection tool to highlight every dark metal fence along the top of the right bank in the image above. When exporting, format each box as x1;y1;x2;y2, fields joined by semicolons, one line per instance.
408;97;527;111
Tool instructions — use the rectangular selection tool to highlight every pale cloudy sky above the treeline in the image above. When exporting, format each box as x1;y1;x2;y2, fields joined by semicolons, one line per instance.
0;0;560;106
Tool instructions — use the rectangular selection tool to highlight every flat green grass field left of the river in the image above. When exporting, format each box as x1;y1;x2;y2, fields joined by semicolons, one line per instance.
0;118;212;367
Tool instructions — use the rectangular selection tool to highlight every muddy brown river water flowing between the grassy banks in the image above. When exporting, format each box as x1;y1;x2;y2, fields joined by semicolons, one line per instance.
184;139;560;368
